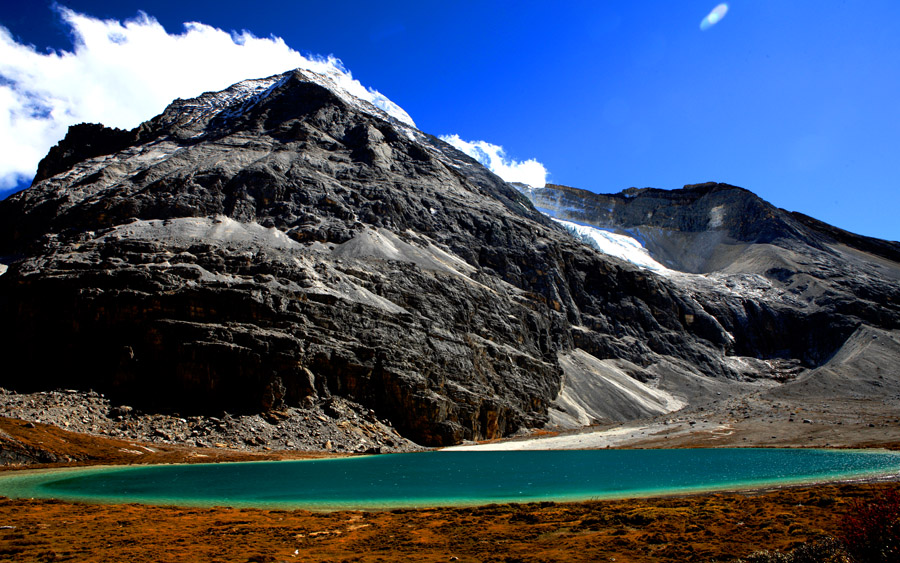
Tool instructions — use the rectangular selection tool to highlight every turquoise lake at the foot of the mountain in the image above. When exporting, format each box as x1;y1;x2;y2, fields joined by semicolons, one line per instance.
0;448;900;510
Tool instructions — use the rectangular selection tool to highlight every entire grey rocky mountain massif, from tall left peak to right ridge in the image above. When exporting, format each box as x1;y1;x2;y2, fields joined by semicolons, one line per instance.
0;70;900;445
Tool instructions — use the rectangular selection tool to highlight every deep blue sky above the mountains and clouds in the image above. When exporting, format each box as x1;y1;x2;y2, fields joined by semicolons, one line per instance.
0;0;900;240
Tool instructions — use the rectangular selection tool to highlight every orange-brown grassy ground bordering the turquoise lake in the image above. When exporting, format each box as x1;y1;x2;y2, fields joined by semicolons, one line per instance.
0;418;900;563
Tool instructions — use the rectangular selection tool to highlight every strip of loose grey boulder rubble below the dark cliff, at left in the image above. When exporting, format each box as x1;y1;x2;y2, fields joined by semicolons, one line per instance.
0;389;422;458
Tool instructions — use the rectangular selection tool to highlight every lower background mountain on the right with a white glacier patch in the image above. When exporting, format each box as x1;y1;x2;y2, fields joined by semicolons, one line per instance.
520;183;900;426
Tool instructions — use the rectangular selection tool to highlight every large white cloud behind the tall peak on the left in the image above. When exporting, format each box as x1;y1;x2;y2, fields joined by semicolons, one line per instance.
0;8;413;190
